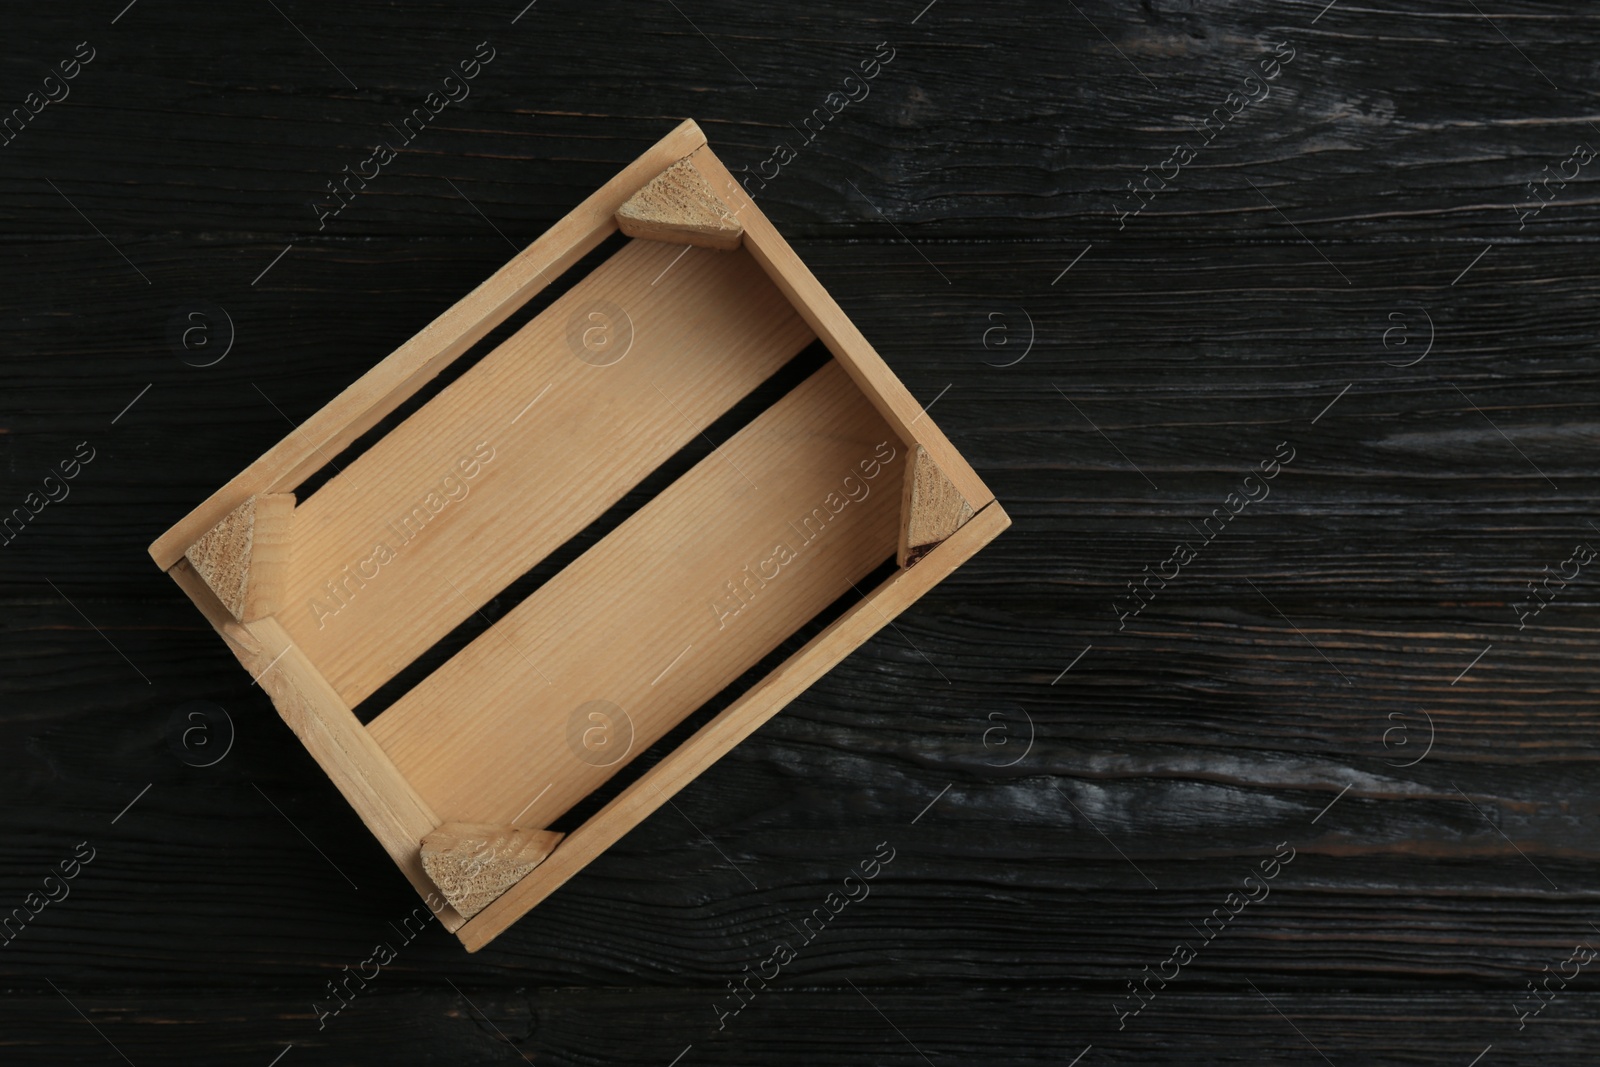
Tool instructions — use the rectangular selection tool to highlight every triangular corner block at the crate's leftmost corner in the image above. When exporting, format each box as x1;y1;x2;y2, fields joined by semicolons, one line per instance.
184;493;294;622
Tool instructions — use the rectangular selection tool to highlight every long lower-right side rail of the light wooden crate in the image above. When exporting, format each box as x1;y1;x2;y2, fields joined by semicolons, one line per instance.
456;502;1011;952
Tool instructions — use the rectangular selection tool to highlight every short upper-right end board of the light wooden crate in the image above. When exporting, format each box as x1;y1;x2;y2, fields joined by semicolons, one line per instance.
690;147;994;509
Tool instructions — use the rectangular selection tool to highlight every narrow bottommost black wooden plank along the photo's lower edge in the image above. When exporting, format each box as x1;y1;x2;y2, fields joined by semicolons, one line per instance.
14;991;1600;1067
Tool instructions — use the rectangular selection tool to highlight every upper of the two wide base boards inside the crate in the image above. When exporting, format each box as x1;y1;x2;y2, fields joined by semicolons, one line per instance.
278;240;813;710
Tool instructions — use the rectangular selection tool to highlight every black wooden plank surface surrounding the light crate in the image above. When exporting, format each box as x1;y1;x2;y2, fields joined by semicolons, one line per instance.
0;0;1600;1067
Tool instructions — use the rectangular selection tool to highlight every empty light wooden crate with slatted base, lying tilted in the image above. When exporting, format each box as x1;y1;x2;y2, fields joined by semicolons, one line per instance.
150;122;1010;950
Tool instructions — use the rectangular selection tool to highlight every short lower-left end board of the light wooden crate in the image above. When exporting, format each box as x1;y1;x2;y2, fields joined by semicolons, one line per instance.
168;560;466;929
